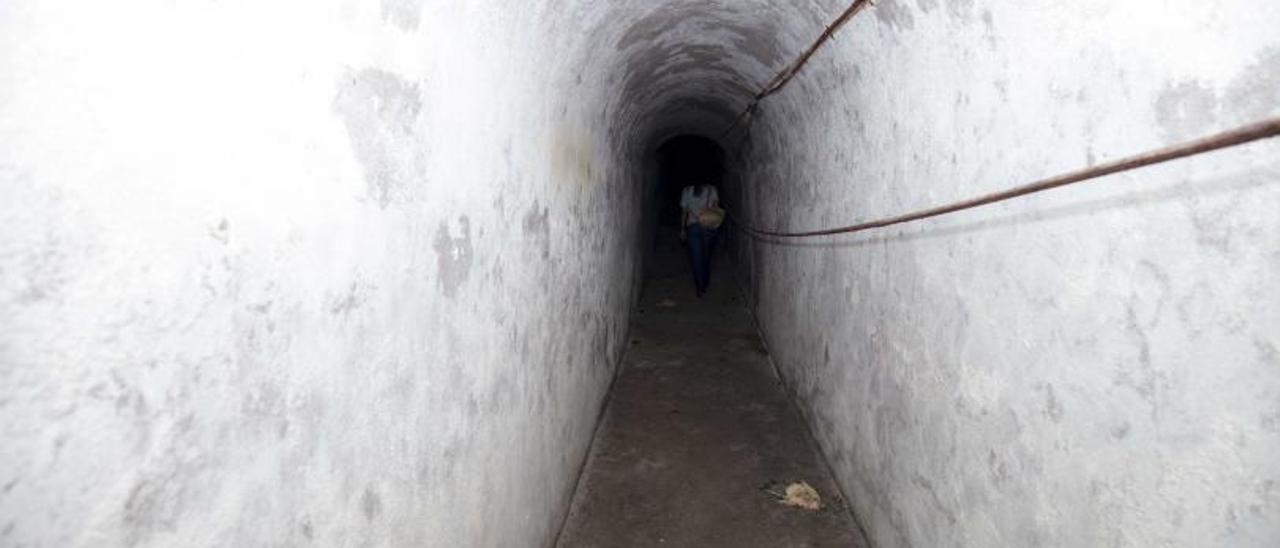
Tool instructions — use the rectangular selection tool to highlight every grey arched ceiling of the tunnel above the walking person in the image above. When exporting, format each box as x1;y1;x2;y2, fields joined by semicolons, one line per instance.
584;0;840;149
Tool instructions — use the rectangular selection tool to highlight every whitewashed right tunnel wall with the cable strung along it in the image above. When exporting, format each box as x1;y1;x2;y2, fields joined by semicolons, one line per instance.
739;0;1280;547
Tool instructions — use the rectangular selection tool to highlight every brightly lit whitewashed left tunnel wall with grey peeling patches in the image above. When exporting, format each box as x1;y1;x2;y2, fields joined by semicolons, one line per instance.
0;0;641;547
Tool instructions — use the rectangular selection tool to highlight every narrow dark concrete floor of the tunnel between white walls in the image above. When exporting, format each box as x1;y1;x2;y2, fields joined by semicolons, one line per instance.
558;233;865;548
